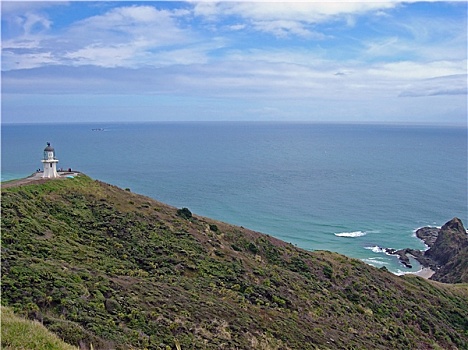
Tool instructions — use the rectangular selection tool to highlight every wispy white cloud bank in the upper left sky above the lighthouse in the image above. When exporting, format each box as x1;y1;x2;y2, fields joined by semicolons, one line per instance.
2;6;200;70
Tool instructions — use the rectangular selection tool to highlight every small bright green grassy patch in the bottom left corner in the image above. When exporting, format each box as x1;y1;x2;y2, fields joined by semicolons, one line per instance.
2;306;78;350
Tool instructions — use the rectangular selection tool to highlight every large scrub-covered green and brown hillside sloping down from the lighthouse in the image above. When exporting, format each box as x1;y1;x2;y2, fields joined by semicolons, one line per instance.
1;175;468;349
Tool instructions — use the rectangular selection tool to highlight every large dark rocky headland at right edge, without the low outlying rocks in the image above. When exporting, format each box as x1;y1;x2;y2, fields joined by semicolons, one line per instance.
424;218;468;283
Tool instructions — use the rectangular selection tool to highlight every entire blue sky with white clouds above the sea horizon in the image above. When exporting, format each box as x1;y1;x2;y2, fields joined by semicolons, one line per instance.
1;1;467;125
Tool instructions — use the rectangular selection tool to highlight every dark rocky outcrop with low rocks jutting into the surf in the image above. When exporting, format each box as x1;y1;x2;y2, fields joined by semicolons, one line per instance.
385;218;468;283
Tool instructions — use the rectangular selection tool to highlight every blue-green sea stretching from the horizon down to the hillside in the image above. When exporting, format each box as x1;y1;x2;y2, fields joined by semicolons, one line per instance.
1;122;468;273
